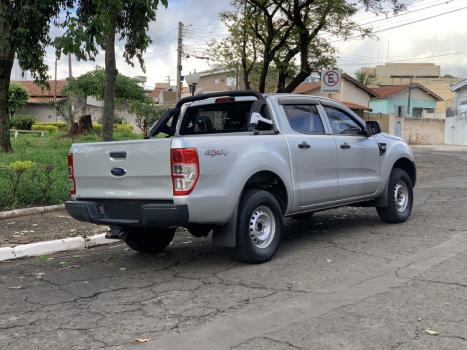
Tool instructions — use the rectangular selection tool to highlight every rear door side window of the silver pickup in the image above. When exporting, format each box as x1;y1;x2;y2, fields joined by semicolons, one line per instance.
284;105;325;134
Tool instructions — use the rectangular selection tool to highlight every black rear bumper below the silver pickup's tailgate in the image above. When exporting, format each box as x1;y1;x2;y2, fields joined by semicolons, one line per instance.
65;200;189;227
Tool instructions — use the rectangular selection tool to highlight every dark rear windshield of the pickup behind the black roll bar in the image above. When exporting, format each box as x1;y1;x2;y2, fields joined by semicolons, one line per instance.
180;101;253;135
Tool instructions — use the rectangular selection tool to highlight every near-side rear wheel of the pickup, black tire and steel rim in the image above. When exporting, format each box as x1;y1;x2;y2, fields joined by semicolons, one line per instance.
233;190;283;264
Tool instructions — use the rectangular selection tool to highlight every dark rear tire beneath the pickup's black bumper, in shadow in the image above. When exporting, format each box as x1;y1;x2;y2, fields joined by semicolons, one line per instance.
124;228;175;254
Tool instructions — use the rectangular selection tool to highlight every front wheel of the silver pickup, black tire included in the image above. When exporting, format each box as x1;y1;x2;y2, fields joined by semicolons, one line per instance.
376;168;413;224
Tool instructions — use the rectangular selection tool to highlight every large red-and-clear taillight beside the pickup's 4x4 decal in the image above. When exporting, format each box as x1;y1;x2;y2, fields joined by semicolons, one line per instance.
170;148;199;196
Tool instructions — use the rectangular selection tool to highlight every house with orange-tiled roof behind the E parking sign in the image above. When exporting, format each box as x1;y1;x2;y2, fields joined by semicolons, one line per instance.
294;73;376;114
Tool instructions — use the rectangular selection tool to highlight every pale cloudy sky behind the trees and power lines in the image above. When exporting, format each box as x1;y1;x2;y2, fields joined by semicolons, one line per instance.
12;0;467;88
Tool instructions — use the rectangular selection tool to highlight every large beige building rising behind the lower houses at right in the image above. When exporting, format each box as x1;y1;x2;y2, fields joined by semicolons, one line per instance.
361;63;460;118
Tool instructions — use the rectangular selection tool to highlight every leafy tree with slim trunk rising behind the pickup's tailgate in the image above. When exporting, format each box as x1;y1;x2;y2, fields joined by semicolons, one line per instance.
55;0;167;141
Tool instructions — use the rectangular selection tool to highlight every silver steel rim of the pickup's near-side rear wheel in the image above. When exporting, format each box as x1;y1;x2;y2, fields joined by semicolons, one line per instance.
248;205;276;249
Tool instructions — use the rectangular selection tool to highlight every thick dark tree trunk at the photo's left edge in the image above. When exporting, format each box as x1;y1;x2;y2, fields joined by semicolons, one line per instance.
0;1;15;152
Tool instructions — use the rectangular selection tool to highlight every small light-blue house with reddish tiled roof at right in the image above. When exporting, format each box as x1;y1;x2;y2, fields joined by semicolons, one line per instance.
370;84;443;118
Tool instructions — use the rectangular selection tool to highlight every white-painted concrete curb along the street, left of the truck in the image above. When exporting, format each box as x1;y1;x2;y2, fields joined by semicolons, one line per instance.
0;233;119;261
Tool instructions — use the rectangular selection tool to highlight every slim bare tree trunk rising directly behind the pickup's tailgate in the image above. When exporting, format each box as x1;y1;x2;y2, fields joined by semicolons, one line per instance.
102;22;117;141
